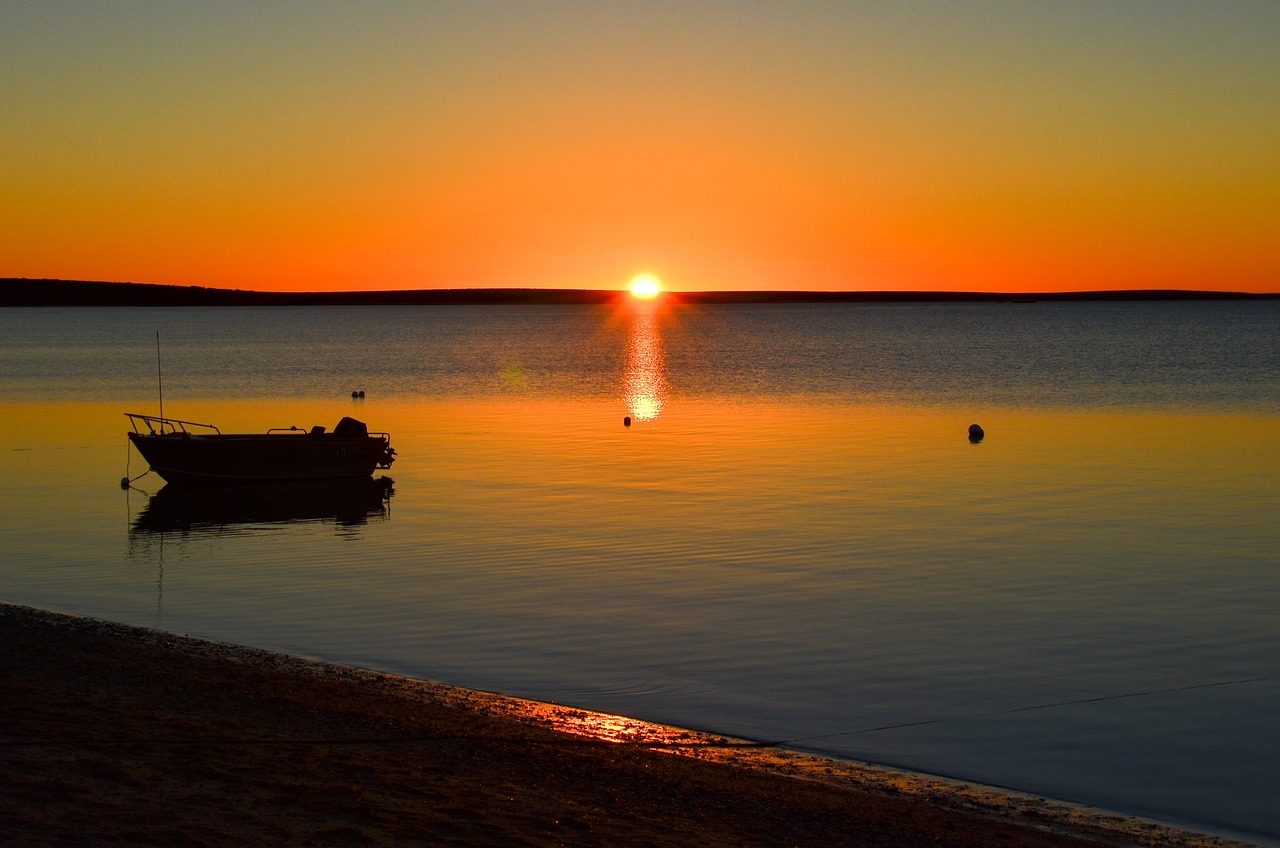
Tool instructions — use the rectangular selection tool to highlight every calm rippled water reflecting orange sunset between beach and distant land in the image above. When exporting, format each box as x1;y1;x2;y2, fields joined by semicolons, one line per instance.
0;302;1280;844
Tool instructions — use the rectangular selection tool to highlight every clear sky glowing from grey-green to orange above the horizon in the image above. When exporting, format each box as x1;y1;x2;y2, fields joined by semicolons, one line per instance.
0;0;1280;292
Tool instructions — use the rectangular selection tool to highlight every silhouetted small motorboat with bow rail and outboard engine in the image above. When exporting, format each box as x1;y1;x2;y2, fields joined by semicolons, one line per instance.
124;412;396;484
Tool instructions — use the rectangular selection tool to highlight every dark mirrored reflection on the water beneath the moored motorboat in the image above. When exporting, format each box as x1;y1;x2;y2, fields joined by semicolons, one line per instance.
131;477;396;533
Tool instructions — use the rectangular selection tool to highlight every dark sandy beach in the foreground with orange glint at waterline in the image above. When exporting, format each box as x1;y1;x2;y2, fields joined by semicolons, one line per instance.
0;603;1249;847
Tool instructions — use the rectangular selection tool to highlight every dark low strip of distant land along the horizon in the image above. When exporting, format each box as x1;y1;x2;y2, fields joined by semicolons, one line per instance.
0;277;1280;306
